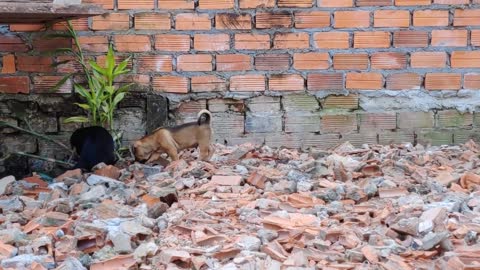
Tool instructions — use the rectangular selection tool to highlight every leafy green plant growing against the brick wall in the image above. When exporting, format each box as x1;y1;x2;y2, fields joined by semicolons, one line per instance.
50;21;131;151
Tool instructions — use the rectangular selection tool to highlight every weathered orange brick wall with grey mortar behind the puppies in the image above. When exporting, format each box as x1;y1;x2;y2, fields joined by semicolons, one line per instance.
0;0;480;177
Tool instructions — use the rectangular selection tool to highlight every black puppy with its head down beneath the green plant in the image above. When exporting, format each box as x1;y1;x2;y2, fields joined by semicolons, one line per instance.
70;126;116;171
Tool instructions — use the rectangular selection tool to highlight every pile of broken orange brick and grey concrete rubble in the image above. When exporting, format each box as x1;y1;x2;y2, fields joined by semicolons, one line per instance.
0;141;480;270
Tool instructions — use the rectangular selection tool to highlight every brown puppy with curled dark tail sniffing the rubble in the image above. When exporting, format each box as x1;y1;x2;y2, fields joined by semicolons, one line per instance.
133;110;214;163
